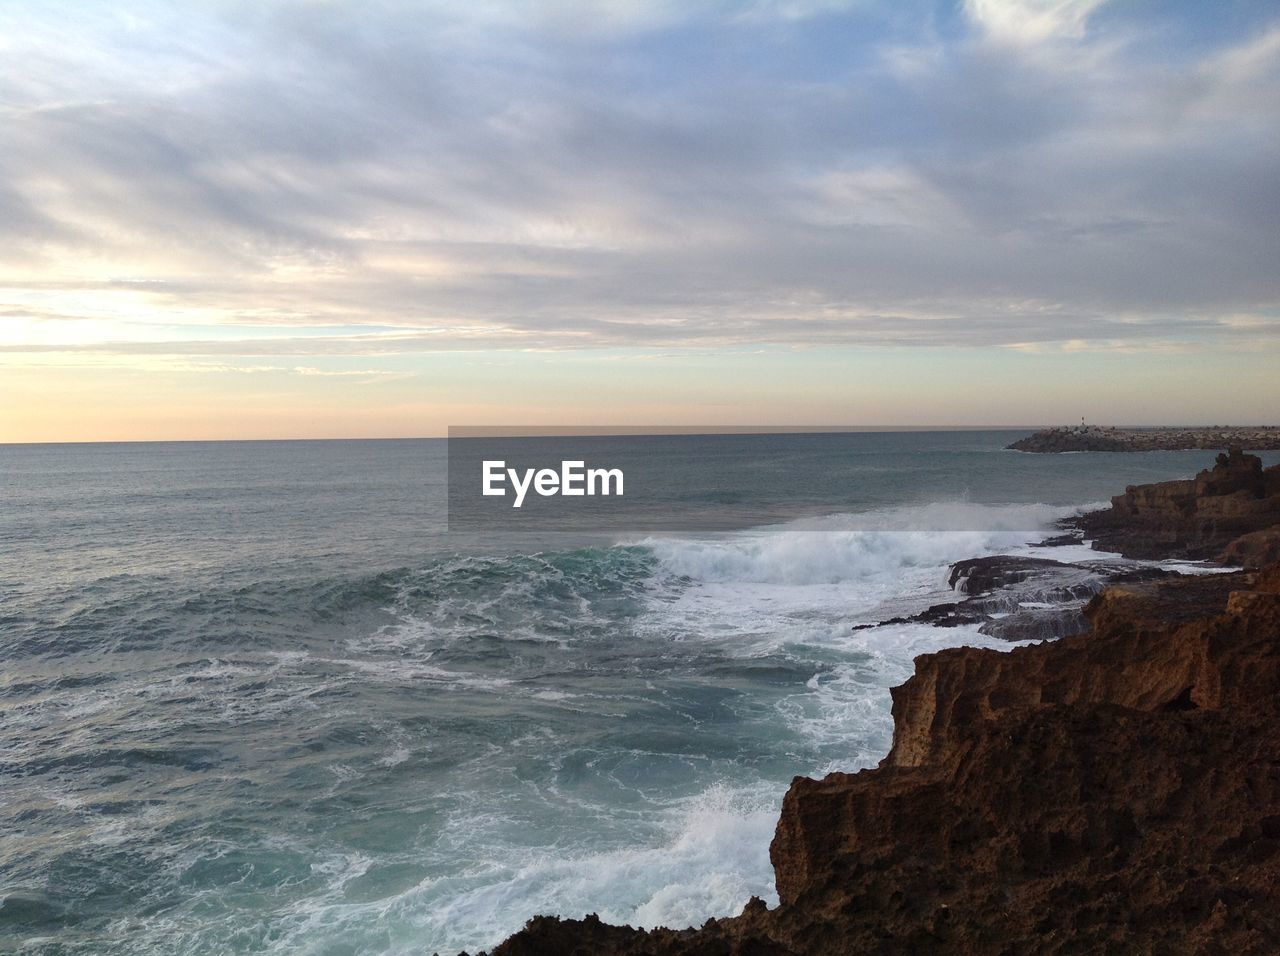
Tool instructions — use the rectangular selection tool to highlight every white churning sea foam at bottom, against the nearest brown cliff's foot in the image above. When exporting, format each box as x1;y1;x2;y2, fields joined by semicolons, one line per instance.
229;785;781;956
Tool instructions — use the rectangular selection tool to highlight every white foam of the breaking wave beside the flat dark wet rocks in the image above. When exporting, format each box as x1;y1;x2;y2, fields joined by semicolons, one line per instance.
636;502;1064;772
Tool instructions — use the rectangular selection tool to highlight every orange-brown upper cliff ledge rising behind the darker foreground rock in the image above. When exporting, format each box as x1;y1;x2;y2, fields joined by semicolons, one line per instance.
884;575;1280;767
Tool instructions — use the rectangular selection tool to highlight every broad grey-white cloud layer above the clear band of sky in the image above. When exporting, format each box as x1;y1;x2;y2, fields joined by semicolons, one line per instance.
0;0;1280;356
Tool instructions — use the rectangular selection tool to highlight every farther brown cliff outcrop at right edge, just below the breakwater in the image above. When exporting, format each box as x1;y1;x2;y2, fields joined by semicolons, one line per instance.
1078;448;1280;567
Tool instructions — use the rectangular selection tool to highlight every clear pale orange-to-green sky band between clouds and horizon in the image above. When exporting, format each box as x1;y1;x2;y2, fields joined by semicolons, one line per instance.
0;349;1276;442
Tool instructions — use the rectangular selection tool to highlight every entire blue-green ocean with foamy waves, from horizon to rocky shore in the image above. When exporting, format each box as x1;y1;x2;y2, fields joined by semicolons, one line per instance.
0;431;1277;956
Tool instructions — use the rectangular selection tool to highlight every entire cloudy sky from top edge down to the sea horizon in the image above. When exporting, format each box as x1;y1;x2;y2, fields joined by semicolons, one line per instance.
0;0;1280;442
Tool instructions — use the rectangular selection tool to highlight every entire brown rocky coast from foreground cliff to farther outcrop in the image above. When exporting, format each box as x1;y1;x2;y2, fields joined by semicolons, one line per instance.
476;449;1280;956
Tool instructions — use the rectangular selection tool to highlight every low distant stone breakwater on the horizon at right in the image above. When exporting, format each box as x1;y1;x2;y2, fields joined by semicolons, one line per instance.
1007;425;1280;453
